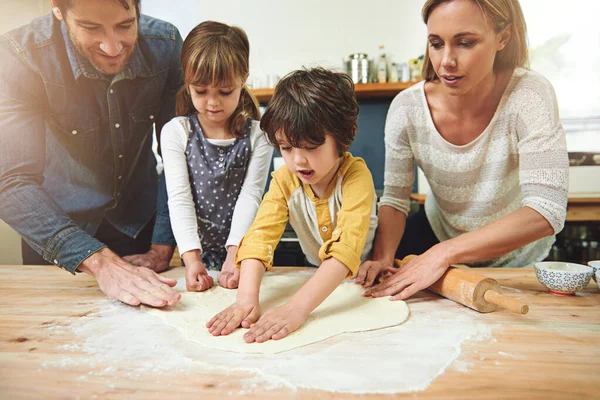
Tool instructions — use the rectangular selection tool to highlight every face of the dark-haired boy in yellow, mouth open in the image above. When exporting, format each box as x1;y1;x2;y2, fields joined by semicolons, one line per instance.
276;132;340;194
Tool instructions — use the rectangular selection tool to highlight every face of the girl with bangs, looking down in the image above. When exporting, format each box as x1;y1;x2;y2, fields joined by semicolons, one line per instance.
189;77;243;127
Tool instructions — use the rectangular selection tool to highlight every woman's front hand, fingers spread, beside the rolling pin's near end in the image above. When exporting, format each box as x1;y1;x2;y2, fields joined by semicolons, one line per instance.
364;244;451;300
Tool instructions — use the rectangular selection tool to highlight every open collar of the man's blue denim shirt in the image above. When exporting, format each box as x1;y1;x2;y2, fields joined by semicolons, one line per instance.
60;22;152;82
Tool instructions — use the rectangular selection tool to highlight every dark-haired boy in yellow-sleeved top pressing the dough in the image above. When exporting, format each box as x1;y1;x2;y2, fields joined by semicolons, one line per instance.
207;68;377;343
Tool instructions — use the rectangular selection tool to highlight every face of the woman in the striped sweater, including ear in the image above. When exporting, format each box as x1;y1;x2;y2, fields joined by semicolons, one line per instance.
427;0;510;95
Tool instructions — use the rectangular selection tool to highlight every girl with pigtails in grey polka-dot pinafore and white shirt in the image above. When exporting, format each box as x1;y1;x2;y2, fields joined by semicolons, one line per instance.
161;21;273;291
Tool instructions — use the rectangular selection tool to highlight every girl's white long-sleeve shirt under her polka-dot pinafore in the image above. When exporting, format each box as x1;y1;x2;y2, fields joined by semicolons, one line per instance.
160;117;273;254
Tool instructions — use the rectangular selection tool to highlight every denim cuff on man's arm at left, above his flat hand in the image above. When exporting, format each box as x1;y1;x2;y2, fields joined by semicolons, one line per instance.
42;228;106;275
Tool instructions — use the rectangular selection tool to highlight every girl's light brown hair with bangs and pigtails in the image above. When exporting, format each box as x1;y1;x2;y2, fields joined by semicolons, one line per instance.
176;21;260;137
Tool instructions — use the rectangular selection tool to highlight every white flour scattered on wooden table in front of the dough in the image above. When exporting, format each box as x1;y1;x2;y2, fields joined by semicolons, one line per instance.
48;272;492;398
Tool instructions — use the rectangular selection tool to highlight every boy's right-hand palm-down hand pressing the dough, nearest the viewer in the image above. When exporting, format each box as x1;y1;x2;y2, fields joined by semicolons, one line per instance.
244;305;308;343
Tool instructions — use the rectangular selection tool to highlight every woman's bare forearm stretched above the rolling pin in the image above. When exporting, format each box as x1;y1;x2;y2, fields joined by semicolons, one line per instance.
441;207;554;264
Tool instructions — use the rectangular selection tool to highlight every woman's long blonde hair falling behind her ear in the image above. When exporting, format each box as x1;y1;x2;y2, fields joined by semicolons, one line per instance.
421;0;528;81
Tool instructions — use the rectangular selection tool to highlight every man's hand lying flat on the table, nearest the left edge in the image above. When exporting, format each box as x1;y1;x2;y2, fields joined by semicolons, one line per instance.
78;248;181;307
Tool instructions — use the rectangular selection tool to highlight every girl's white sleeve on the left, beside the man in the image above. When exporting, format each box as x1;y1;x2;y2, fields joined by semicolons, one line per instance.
160;117;202;254
